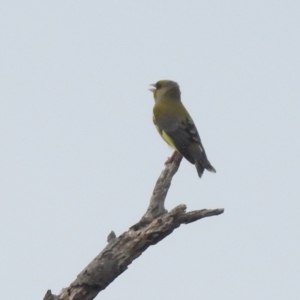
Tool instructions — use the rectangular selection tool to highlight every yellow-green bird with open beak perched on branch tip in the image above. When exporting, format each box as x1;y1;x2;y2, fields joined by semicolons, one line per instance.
150;80;216;177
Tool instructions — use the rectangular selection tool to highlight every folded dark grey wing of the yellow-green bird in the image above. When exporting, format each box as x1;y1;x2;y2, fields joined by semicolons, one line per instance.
153;117;205;163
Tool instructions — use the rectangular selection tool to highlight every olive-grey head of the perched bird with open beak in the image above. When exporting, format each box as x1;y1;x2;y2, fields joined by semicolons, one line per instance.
149;80;180;102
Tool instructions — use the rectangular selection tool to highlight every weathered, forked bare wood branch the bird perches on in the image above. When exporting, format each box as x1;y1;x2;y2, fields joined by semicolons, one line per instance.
44;153;224;300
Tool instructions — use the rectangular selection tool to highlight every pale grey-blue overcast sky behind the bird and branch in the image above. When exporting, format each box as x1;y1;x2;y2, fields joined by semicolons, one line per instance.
0;0;300;300
